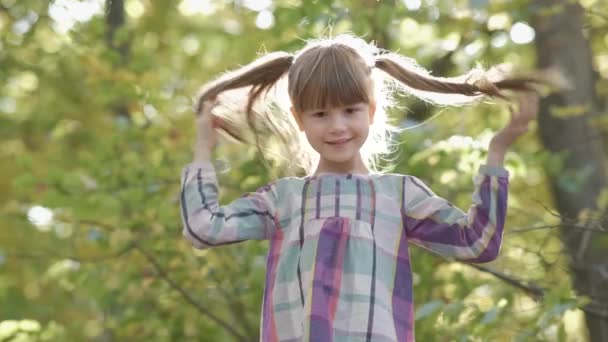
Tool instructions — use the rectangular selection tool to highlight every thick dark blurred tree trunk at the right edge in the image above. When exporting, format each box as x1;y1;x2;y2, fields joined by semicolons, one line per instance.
533;0;608;341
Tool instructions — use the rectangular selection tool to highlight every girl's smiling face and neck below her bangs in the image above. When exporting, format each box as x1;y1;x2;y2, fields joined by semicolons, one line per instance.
292;102;376;173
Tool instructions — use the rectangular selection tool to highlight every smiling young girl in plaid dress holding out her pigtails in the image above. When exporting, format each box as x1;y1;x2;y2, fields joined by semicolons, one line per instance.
181;35;537;342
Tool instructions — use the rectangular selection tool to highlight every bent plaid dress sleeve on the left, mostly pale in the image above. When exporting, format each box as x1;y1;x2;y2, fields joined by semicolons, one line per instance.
180;162;277;249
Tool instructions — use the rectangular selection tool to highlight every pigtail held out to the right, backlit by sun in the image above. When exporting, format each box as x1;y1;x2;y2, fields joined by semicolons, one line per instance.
375;53;544;104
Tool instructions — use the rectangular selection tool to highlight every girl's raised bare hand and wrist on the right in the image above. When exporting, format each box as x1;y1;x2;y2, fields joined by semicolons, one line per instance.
491;93;538;149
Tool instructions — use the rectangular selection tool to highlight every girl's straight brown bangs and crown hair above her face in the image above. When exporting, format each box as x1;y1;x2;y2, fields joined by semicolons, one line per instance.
289;45;372;112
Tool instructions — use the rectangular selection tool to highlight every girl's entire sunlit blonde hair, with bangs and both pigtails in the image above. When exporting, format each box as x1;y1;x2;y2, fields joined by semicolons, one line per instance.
195;34;542;174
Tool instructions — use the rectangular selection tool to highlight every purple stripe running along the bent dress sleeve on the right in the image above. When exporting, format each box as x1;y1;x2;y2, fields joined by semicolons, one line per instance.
404;177;494;247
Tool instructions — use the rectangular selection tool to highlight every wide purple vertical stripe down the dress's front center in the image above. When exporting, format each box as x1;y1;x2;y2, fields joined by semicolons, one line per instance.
310;217;348;342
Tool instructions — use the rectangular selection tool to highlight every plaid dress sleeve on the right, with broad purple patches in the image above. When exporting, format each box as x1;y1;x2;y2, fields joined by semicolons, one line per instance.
402;165;509;263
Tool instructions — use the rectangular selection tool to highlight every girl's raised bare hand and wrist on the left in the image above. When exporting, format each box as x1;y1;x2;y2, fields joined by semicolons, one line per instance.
194;100;219;160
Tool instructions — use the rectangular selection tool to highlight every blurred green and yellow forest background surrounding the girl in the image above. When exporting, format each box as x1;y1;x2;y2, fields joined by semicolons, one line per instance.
0;0;608;341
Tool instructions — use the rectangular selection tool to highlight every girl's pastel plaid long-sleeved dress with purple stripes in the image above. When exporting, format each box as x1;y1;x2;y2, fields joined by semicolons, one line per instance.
181;162;509;342
